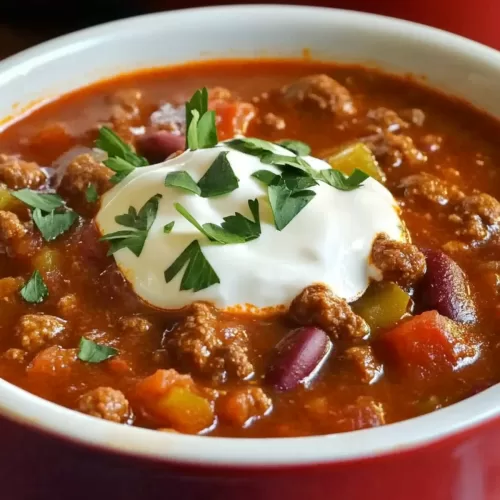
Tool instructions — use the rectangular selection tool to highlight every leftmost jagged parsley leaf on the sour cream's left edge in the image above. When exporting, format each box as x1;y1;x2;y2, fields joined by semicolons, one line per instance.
101;194;162;257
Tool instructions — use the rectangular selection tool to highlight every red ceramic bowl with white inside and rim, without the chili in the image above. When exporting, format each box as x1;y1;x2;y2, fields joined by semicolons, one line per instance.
0;6;500;500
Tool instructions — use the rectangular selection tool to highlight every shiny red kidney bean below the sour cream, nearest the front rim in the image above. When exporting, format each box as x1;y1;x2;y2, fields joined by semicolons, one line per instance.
266;327;332;391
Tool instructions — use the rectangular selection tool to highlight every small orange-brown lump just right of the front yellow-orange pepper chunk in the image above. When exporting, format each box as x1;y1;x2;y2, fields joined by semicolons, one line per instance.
217;387;273;427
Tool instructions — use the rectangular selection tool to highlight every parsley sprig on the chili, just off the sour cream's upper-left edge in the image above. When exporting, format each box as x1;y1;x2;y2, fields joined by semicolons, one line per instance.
95;127;148;183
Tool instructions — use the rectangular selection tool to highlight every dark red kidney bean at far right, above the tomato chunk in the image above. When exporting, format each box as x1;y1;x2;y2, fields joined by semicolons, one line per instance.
415;250;476;323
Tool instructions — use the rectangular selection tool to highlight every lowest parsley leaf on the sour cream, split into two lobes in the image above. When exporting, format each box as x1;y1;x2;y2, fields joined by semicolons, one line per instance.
165;240;220;292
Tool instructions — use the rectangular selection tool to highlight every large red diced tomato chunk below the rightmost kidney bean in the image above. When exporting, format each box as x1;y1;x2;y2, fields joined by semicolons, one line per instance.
380;311;478;379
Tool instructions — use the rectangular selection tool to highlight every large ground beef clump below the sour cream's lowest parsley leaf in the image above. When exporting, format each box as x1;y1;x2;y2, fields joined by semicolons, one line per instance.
167;302;254;381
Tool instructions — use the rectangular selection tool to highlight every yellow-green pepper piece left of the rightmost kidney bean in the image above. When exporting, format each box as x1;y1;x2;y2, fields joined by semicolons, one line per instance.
352;282;410;331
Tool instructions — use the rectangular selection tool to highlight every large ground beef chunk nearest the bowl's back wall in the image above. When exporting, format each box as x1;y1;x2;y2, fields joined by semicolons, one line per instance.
281;75;356;115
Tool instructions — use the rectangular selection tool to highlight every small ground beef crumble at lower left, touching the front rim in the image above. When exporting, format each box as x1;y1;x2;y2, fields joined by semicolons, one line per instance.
78;387;131;424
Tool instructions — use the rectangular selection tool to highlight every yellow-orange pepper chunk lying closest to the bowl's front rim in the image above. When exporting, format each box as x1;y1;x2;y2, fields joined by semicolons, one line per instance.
155;387;214;434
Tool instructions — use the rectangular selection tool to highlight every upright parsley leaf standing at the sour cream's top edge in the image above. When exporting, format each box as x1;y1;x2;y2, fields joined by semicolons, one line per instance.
186;88;218;151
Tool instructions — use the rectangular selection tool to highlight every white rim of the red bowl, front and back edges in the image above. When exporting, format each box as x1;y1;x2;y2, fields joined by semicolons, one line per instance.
0;4;500;468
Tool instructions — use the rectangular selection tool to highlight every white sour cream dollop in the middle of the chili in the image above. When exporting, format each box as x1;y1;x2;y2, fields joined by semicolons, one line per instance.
96;143;406;309
